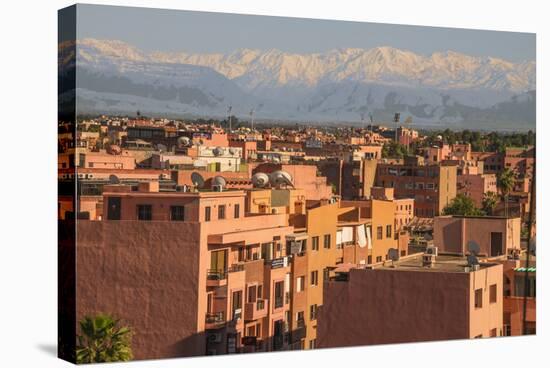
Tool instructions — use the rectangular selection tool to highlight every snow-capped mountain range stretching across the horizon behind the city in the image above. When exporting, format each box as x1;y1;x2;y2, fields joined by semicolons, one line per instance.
60;39;536;129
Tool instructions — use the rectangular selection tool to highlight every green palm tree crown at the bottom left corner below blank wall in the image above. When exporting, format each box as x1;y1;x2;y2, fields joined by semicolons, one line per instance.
76;314;132;364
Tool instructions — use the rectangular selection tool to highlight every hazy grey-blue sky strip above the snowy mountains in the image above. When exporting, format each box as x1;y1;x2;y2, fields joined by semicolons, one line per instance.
67;5;535;62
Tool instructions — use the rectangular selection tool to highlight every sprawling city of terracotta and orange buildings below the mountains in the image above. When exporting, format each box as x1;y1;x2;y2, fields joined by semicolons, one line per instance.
58;114;536;359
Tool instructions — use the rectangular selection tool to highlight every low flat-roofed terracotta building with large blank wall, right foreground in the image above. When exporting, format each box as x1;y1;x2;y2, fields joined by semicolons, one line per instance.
317;254;503;348
